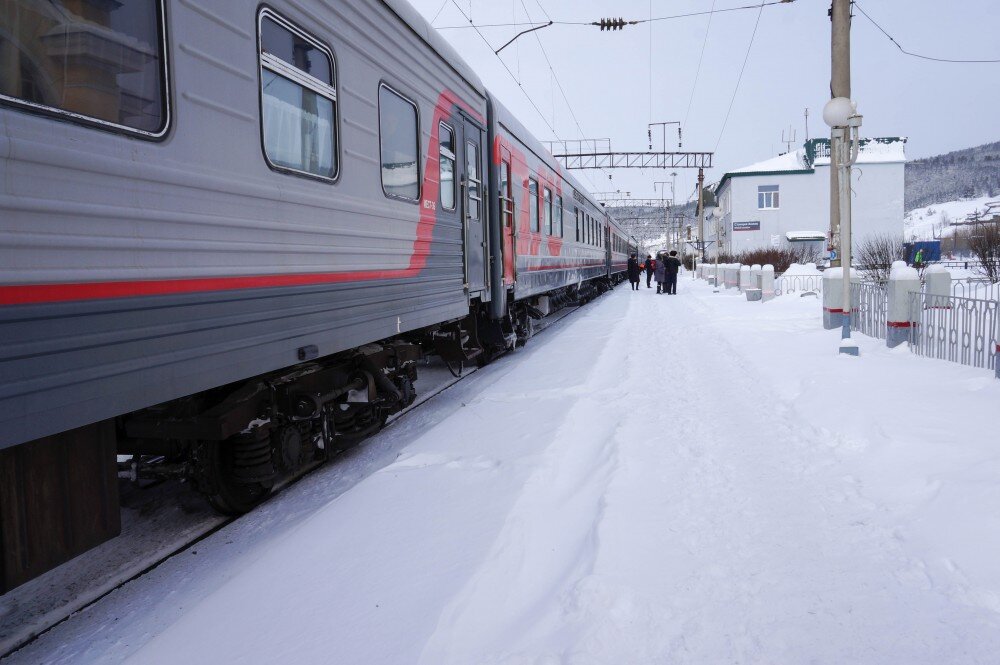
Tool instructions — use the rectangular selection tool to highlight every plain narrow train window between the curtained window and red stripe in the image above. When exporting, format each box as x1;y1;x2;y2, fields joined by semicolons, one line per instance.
378;83;420;201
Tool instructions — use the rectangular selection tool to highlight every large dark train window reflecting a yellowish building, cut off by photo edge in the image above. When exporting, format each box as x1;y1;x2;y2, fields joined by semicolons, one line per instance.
0;0;169;138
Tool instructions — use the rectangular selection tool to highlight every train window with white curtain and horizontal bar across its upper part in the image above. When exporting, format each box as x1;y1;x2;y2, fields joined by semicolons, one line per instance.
260;10;337;179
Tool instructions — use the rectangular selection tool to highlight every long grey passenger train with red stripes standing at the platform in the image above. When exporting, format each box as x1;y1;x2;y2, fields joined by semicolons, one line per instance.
0;0;637;592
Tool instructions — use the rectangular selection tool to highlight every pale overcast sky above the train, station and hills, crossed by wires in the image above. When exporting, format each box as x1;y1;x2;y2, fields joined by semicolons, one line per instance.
410;0;1000;201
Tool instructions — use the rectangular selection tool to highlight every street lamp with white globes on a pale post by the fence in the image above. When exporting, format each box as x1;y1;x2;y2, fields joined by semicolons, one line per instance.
823;97;861;356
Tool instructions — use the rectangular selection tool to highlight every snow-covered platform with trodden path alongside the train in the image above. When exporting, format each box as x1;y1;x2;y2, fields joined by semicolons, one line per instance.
10;277;1000;665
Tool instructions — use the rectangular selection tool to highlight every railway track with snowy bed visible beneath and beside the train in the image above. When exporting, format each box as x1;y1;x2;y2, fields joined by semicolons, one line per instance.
0;307;578;660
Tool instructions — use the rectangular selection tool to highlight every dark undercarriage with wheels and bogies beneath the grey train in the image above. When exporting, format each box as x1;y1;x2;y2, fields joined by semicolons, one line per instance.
0;278;613;593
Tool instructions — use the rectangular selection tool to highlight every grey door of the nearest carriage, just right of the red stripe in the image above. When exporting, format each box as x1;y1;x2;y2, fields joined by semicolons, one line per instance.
462;118;490;293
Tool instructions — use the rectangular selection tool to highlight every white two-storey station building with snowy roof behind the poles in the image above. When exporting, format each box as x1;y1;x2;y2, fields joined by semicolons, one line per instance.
705;138;906;255
